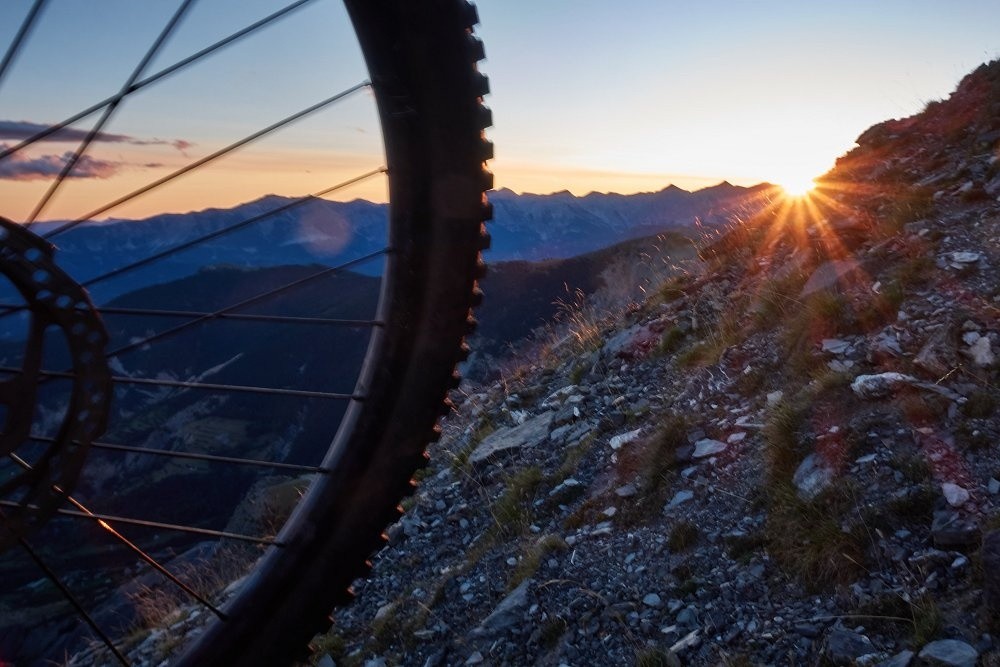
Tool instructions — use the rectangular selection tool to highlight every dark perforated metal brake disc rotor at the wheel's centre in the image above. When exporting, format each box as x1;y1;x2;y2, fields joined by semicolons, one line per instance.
0;218;112;551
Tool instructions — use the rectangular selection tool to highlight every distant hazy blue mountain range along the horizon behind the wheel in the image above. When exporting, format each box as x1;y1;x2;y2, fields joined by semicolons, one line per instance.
29;182;773;301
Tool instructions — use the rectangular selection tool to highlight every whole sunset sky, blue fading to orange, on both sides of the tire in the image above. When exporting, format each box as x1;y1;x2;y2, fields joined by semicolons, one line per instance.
0;0;1000;219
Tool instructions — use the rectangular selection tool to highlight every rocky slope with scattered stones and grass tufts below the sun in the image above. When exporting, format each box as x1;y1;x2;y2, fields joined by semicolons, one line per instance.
314;61;1000;667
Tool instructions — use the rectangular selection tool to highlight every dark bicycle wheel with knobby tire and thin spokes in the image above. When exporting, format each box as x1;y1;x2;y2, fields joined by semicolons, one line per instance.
0;0;491;665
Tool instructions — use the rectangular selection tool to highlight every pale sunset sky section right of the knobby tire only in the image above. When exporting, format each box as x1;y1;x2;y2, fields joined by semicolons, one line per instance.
478;0;1000;193
